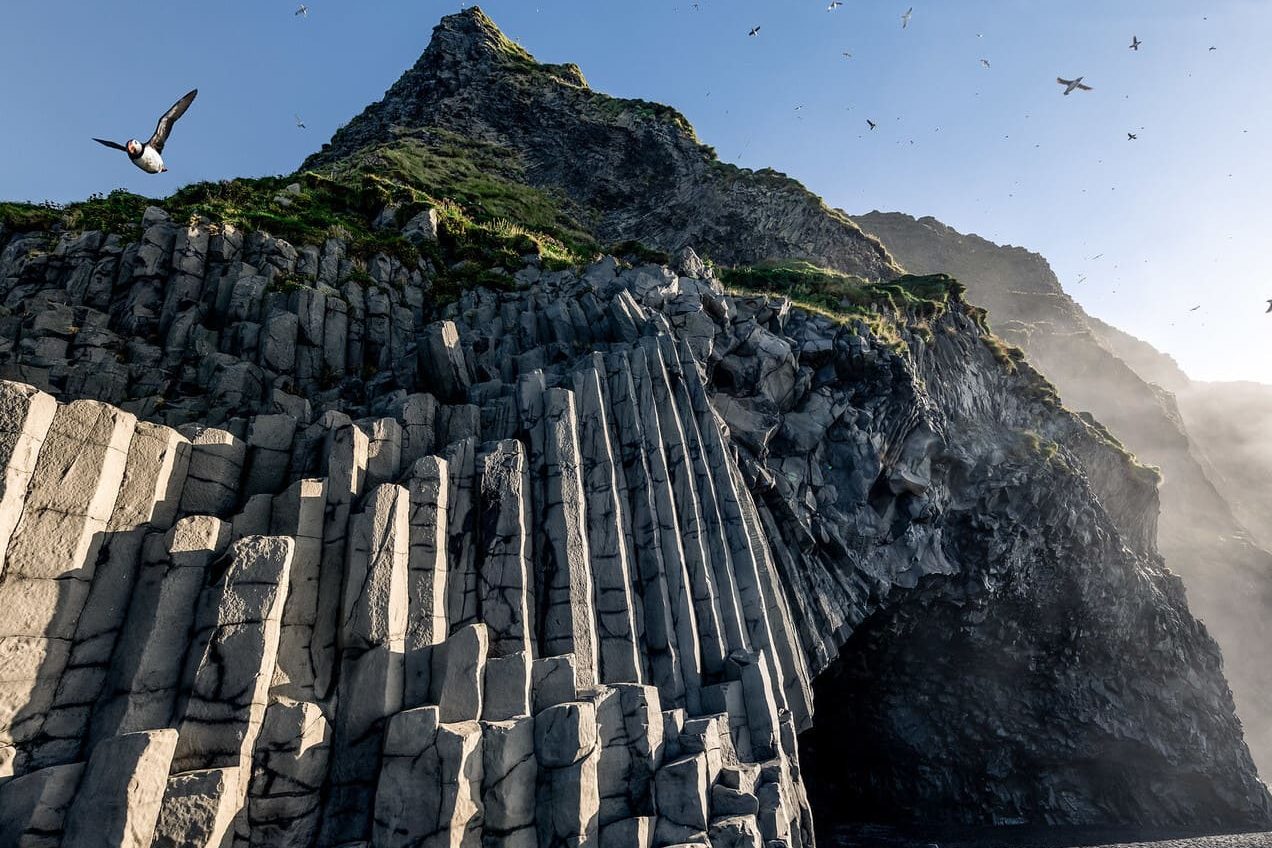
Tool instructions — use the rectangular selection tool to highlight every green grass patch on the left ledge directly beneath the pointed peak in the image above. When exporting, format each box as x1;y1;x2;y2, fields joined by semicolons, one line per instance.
0;131;599;301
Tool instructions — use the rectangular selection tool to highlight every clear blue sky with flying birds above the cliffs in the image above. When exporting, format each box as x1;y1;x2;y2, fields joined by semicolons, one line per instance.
0;0;1272;383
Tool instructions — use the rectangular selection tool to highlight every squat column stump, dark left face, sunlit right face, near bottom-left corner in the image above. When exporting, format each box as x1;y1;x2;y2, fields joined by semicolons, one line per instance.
62;730;177;848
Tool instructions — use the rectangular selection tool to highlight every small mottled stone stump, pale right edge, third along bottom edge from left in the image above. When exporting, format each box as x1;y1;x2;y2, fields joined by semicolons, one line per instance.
150;768;239;848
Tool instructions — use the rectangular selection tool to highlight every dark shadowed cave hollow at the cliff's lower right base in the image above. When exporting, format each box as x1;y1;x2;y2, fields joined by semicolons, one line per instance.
800;584;1261;845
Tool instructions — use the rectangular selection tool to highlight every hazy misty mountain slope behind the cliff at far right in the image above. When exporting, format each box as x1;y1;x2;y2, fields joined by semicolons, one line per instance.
855;212;1272;773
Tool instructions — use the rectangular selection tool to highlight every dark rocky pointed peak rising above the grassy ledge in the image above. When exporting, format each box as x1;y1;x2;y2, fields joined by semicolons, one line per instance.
305;8;897;278
